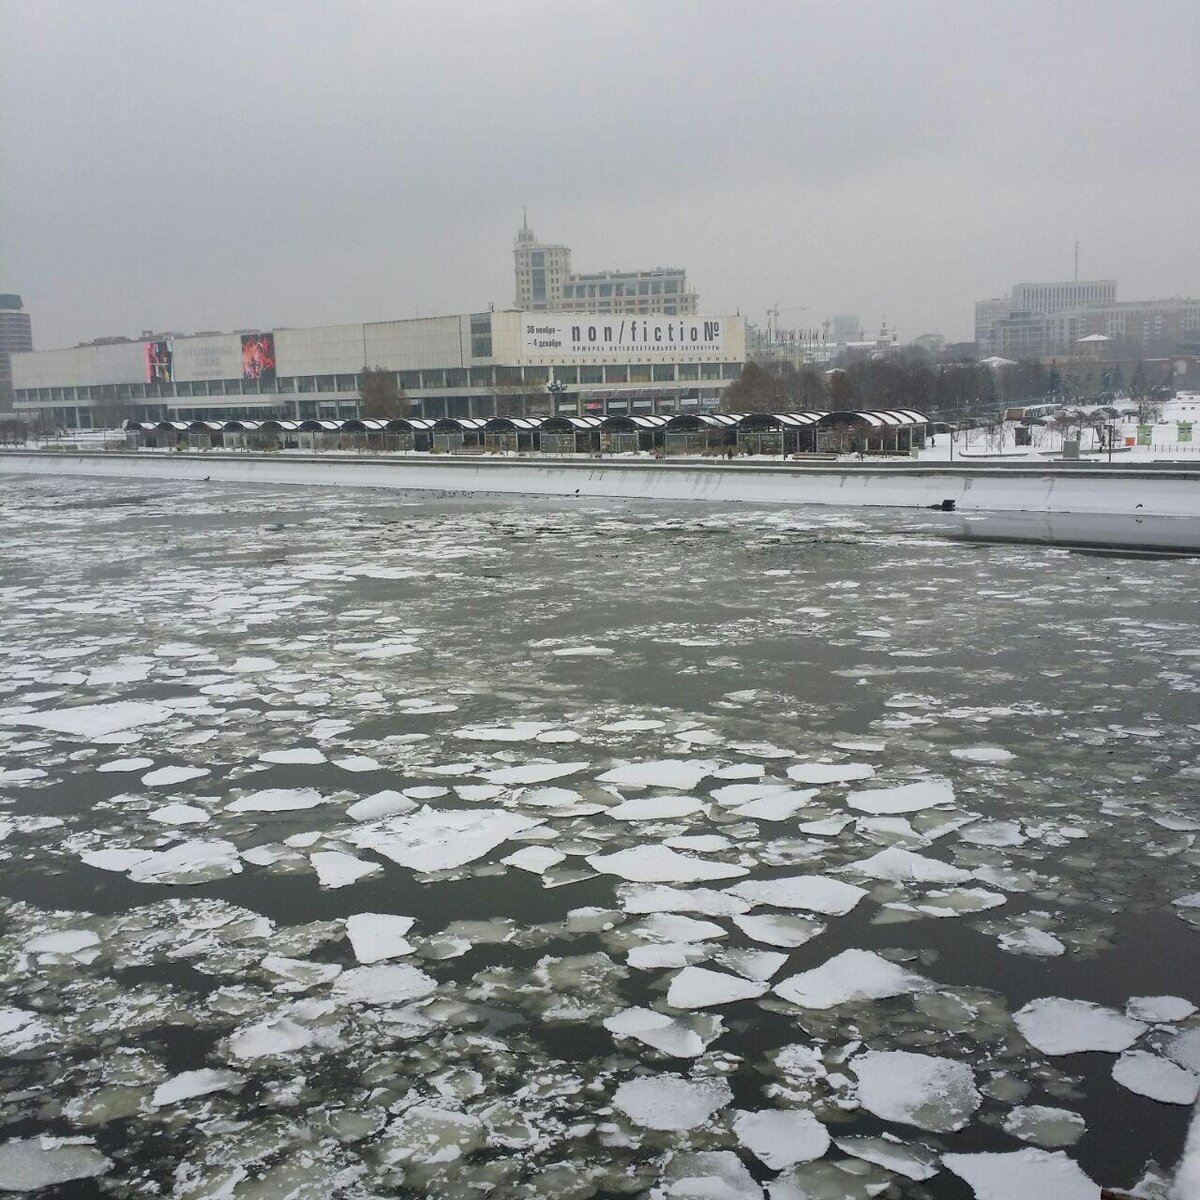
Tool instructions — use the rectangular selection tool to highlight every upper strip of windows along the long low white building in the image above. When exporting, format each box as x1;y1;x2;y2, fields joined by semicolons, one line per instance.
16;362;742;403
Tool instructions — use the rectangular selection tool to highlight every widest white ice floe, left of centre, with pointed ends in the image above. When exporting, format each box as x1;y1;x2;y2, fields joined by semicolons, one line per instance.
346;808;541;871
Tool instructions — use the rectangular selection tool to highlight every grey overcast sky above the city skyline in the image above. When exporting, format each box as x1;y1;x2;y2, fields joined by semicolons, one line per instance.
0;0;1200;348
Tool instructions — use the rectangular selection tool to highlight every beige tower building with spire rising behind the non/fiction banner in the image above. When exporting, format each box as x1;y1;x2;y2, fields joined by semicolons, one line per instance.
512;221;700;317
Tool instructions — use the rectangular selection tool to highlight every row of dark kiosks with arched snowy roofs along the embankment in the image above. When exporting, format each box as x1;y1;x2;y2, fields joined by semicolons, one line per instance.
125;409;929;455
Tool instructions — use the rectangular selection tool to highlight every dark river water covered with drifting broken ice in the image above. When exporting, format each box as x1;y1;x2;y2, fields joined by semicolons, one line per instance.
0;479;1200;1200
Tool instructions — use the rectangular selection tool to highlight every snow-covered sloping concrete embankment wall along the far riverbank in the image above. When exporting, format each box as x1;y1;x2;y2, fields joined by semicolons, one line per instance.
0;450;1200;517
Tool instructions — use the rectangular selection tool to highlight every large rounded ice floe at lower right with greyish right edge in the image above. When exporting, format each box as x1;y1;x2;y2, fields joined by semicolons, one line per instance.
850;1050;979;1132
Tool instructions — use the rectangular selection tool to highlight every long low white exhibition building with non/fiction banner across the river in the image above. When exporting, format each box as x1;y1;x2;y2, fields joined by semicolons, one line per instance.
13;310;745;428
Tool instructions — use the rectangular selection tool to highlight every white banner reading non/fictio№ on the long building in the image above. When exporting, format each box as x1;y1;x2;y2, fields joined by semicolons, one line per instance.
521;312;726;359
